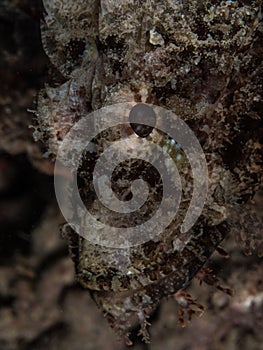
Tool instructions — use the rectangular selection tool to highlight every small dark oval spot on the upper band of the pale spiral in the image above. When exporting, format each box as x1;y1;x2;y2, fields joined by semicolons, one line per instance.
129;103;156;137
